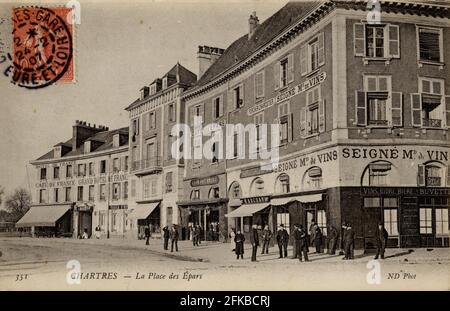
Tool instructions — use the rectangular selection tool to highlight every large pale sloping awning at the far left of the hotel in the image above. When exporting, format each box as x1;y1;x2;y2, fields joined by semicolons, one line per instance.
16;205;71;227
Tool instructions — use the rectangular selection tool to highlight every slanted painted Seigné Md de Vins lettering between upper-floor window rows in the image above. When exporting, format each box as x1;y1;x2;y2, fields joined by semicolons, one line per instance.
247;72;327;116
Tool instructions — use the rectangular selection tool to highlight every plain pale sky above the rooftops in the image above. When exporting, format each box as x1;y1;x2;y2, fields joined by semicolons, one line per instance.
0;0;287;204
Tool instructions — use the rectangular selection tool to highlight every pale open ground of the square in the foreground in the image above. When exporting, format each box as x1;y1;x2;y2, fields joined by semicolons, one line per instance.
0;238;450;290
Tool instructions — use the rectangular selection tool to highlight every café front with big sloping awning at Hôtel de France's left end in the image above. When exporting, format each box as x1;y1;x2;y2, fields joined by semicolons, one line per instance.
16;204;73;237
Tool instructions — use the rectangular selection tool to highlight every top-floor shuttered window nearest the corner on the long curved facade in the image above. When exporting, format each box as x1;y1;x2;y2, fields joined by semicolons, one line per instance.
300;33;325;76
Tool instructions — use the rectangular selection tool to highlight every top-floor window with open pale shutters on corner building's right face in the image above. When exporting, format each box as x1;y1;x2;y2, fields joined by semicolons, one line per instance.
353;23;400;59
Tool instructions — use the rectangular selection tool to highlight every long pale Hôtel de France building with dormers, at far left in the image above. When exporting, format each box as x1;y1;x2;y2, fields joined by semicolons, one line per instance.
16;120;130;238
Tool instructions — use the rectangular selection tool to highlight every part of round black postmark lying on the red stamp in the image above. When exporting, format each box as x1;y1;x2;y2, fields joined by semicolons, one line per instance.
12;7;73;89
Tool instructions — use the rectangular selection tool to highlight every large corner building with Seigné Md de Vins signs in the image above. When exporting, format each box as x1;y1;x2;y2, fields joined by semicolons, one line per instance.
180;1;450;248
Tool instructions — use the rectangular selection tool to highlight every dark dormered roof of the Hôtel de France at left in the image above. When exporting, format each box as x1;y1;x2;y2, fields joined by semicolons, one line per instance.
36;126;129;161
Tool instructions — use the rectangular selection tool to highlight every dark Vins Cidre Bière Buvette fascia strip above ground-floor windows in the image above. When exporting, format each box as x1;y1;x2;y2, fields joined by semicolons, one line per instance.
361;187;450;196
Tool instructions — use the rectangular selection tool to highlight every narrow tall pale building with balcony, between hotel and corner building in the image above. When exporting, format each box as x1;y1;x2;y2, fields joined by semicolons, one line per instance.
126;63;197;236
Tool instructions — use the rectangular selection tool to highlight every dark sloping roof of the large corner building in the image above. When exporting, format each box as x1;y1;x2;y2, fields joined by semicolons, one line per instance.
194;1;323;87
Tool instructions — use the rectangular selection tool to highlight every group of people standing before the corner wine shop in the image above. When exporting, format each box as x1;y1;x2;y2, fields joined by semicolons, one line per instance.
229;220;388;261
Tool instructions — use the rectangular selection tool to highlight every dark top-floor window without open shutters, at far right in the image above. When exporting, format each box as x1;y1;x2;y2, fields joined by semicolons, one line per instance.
417;27;444;63
